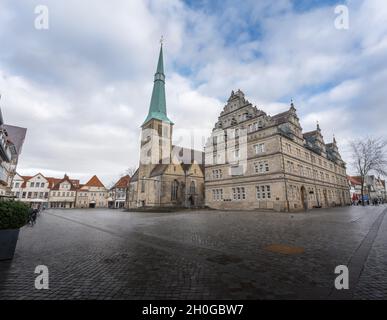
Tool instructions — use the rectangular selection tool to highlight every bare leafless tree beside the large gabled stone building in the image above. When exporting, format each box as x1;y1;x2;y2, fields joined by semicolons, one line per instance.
350;138;387;205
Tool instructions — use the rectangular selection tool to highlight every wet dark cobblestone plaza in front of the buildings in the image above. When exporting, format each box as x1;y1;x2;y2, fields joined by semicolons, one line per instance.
0;206;387;299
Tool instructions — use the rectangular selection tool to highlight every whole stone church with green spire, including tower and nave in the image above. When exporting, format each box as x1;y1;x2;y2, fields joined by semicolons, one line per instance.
127;44;204;209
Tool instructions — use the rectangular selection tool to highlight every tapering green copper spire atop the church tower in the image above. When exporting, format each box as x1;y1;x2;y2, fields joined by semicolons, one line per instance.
143;43;173;125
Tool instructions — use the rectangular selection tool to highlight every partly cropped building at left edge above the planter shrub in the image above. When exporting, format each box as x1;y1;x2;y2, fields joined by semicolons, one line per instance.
0;104;27;200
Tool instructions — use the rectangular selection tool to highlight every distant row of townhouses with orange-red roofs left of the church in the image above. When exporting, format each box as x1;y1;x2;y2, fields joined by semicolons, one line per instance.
12;173;129;208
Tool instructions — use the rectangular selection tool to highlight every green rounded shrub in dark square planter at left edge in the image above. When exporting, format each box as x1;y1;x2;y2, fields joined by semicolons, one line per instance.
0;201;30;260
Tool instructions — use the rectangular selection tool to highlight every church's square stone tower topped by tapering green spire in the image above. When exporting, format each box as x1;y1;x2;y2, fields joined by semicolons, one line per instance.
138;43;173;205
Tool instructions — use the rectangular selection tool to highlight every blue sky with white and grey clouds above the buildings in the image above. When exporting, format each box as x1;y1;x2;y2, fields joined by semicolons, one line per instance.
0;0;387;185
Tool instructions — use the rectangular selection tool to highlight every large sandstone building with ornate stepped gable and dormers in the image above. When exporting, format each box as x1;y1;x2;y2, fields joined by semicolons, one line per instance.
205;90;350;211
